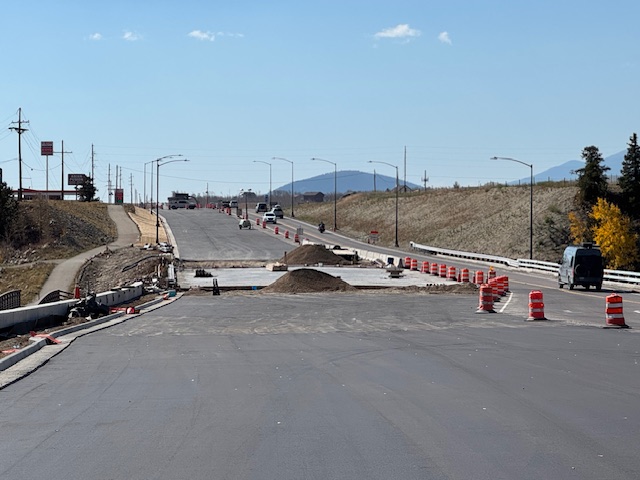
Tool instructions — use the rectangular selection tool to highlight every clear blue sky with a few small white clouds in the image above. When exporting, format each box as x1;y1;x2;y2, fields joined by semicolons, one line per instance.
0;0;640;202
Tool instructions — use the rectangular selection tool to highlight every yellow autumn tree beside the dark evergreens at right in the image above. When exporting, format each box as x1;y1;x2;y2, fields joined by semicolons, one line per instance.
589;198;638;269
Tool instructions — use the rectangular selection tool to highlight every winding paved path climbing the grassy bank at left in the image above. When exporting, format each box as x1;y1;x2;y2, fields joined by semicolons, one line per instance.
32;205;140;304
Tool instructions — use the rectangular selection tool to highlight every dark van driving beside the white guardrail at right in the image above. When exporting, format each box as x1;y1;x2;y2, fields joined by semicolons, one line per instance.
558;242;604;291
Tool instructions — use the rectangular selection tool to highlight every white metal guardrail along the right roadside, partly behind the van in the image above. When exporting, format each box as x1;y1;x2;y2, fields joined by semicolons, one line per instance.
410;242;640;285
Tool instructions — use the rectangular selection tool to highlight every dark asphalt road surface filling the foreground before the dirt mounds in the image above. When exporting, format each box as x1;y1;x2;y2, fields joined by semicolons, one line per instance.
0;293;640;480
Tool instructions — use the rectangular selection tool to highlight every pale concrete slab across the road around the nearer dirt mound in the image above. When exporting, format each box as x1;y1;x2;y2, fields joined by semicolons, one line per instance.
178;265;456;289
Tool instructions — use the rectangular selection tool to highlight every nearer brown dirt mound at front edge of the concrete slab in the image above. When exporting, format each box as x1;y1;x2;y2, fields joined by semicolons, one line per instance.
260;268;357;293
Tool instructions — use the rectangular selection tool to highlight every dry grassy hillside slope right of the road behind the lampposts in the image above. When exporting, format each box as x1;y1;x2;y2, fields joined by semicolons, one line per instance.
296;186;576;261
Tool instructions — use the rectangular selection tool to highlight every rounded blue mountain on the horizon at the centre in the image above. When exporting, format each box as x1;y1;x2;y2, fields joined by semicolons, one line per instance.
274;170;420;195
